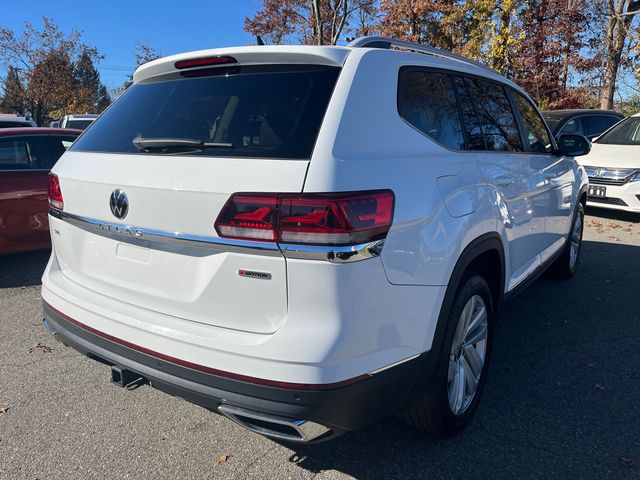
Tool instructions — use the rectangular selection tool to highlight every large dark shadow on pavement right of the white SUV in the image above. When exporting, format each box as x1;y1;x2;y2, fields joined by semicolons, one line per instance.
288;241;640;479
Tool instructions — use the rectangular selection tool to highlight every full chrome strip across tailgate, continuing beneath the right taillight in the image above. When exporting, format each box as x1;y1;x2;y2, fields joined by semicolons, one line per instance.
49;207;384;263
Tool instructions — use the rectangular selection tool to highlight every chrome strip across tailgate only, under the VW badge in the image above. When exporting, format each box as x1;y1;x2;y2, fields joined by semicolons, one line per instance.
49;208;282;256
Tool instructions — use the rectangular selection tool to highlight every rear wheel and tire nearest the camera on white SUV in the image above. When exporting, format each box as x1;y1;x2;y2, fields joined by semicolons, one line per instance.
399;273;494;437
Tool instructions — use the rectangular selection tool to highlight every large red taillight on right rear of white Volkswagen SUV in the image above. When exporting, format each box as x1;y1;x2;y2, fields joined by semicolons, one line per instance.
215;190;394;245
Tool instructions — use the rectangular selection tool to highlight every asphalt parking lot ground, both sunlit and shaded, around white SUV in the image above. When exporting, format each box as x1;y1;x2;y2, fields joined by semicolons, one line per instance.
0;206;640;480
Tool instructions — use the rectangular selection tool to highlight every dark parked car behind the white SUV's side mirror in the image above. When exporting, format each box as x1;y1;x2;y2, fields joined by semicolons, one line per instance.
542;110;624;140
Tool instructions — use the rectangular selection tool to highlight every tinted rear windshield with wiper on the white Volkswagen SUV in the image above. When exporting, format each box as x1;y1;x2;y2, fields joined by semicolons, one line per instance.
71;65;340;159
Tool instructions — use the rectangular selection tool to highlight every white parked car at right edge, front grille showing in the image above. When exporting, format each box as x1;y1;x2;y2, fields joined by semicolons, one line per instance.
580;114;640;212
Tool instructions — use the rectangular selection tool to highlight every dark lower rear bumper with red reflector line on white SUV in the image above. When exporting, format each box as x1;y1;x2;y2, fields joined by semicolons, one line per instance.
44;303;428;442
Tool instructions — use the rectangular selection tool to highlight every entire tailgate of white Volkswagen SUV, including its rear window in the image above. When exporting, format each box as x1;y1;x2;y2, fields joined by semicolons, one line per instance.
52;65;339;334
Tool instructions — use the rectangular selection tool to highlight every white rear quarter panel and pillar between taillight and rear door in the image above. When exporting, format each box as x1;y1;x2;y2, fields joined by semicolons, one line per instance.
304;49;499;285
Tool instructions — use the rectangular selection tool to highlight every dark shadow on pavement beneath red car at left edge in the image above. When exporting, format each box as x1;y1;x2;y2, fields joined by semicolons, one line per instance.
0;250;51;288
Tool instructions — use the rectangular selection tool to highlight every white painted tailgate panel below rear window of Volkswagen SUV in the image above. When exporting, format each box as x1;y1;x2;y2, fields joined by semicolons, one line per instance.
52;152;307;333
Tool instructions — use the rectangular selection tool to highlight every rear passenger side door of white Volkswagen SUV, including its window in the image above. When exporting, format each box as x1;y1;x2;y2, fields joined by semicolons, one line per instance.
456;77;549;288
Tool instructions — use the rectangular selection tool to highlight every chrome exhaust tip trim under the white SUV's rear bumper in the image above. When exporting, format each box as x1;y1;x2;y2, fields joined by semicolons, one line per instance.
218;405;330;443
